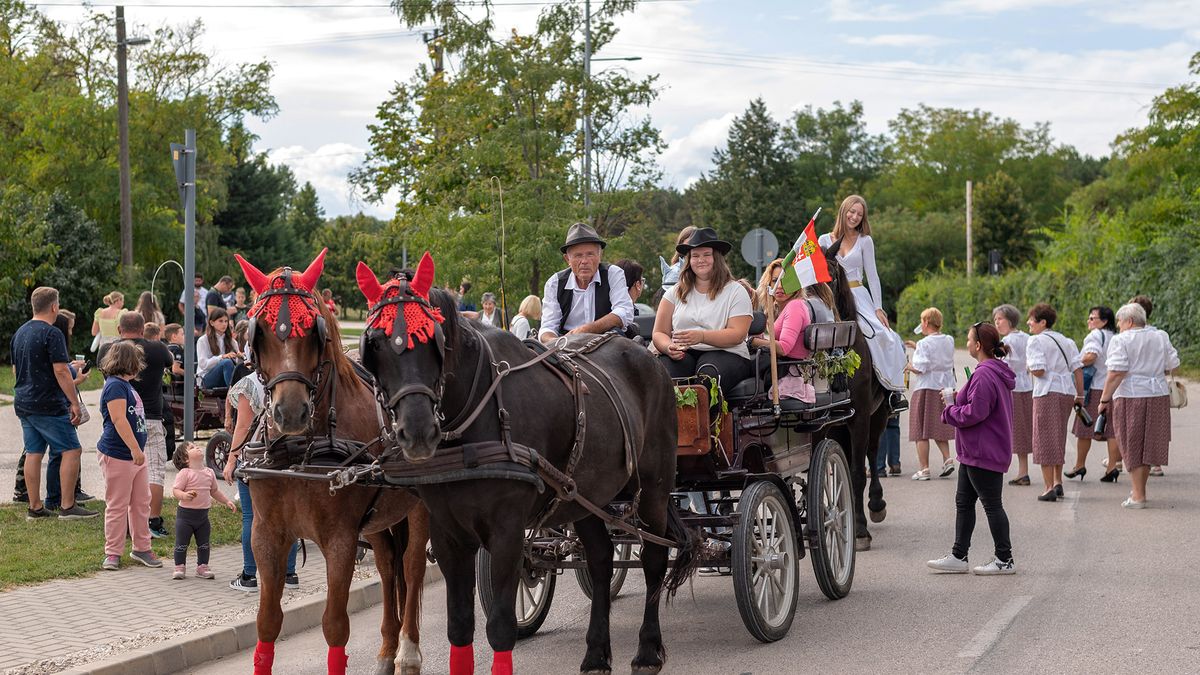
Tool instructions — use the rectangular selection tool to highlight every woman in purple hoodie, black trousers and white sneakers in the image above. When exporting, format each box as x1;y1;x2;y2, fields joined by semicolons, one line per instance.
928;322;1016;575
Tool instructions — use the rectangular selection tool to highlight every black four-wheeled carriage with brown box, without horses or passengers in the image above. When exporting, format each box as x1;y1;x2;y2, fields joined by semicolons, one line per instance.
476;315;857;643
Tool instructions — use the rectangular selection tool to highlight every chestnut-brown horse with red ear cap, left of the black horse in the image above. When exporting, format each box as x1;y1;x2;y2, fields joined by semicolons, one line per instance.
238;251;430;675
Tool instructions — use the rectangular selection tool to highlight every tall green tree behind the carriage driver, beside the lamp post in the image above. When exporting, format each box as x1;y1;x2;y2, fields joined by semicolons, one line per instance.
352;0;660;295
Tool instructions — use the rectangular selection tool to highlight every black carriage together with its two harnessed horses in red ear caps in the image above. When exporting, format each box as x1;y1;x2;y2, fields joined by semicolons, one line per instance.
231;248;882;675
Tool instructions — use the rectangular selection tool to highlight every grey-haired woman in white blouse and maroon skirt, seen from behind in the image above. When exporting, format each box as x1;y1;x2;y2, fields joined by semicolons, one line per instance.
1099;303;1180;508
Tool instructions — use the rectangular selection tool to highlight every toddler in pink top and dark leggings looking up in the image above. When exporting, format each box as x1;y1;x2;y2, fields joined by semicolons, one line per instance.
172;443;238;579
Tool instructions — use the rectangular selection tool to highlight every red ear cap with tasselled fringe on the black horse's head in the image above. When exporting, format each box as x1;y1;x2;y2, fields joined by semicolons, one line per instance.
356;251;445;350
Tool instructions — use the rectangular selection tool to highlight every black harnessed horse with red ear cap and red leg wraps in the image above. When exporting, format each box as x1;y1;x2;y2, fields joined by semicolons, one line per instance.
359;253;695;675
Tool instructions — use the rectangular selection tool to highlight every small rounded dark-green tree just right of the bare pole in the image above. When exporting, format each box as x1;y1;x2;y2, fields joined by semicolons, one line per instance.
972;171;1037;271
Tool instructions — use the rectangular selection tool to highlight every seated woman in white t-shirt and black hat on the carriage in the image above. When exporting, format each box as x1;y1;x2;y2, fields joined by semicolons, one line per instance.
654;227;754;392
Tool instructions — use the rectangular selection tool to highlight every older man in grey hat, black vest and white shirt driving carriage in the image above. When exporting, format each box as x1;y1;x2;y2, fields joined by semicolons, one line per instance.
538;222;634;342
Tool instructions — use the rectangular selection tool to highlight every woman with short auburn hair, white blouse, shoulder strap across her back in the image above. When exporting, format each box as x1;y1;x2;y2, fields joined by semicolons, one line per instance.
1025;303;1084;502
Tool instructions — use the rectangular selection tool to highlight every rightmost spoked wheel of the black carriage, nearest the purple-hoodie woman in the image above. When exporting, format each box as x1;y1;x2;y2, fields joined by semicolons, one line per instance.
805;438;854;601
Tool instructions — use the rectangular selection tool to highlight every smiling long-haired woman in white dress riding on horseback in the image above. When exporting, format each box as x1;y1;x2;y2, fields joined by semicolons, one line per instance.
818;195;907;392
